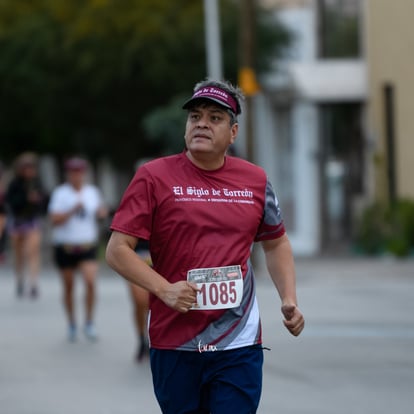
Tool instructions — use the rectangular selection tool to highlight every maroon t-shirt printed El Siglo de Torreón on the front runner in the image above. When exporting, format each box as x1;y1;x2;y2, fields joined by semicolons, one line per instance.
111;152;285;351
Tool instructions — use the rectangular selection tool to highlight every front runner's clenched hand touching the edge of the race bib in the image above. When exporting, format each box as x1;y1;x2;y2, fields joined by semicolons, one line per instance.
160;280;199;313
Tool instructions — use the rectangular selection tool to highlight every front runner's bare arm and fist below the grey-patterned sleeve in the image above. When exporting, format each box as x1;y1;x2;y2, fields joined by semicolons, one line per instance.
262;234;305;336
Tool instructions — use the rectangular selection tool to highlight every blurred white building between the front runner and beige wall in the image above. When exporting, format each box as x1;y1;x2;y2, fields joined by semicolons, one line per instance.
241;0;368;256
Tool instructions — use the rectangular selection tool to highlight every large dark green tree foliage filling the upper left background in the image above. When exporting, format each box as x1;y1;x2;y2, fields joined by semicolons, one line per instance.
0;0;287;169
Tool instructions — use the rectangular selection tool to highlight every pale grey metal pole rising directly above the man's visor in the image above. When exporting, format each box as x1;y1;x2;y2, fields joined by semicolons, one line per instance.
204;0;223;80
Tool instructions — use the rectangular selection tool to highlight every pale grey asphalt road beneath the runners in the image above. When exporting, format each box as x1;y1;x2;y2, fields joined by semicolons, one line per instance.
0;258;414;414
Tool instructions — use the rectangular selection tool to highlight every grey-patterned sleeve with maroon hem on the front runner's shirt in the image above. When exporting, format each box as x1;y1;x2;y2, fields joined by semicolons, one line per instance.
255;180;286;241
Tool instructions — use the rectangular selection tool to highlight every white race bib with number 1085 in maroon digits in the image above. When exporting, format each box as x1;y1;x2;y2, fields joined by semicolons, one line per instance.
187;265;243;310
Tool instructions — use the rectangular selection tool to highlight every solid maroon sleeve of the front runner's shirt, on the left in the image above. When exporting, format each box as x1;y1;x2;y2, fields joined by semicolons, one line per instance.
110;167;155;240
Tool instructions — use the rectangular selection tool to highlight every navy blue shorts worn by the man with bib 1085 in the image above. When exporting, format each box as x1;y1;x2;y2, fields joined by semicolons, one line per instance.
150;345;263;414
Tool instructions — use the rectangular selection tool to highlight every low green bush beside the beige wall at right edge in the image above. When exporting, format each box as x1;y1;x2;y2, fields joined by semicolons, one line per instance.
356;199;414;257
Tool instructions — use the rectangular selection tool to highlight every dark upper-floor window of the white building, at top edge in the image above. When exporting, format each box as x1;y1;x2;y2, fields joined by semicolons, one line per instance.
317;0;362;58
